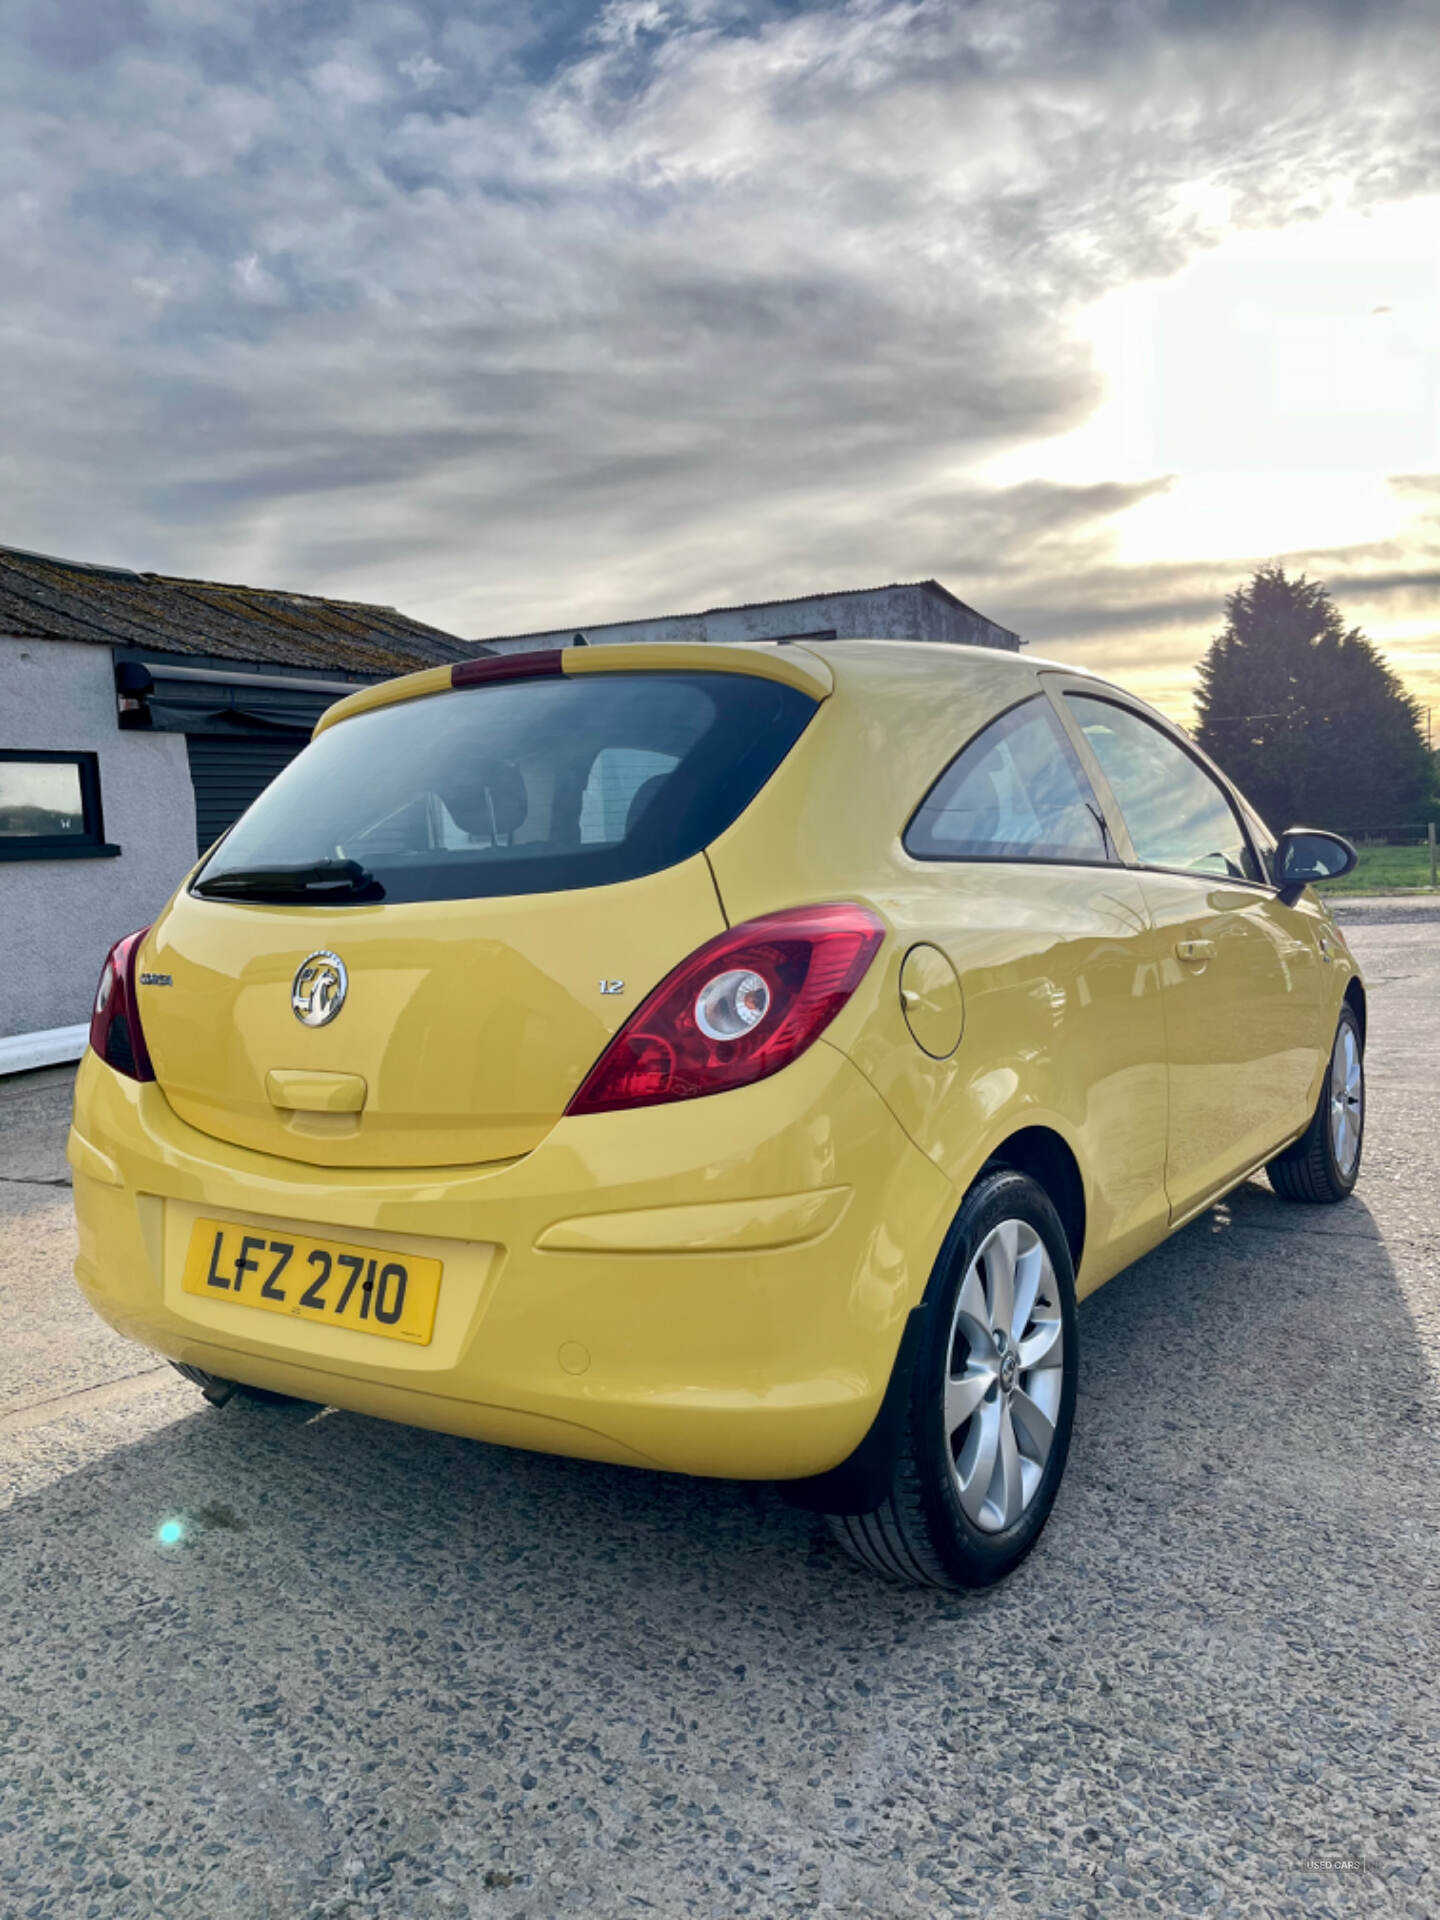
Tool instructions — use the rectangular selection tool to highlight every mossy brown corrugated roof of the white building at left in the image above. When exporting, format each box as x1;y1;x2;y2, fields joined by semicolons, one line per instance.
0;547;474;674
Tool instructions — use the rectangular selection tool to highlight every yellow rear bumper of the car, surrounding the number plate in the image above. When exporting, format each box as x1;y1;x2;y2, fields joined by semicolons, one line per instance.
69;1041;956;1478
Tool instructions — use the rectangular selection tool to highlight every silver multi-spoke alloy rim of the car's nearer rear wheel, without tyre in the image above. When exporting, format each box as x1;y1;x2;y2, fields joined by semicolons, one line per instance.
945;1219;1066;1534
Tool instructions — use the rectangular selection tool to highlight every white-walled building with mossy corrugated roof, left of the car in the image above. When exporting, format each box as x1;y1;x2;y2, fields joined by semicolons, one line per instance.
0;547;464;1073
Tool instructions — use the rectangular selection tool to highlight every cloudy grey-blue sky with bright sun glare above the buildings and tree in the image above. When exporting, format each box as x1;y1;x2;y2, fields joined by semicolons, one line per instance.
0;0;1440;721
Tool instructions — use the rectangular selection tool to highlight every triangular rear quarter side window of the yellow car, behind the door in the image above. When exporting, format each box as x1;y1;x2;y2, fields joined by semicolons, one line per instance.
904;695;1114;860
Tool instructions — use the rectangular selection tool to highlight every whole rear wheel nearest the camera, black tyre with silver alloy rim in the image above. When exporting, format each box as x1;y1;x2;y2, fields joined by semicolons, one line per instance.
828;1167;1079;1588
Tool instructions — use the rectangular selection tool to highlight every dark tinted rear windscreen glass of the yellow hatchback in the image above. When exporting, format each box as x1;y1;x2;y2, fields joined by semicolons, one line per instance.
196;672;816;904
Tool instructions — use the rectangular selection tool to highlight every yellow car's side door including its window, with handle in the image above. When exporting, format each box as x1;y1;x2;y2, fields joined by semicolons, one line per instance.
1064;685;1321;1219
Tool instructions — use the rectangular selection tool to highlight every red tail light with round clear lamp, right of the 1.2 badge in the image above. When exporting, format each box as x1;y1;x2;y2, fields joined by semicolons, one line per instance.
566;906;885;1114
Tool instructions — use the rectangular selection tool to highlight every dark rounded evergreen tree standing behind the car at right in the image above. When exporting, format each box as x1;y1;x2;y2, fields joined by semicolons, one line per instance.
1196;566;1432;831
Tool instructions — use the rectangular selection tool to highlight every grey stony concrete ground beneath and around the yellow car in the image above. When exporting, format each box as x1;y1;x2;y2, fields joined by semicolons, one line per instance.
0;902;1440;1920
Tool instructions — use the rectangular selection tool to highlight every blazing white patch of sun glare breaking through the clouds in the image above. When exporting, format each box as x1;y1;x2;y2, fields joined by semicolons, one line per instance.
987;198;1440;564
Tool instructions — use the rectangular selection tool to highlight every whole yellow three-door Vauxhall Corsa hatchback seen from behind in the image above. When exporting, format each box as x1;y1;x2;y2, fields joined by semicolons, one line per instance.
69;639;1365;1588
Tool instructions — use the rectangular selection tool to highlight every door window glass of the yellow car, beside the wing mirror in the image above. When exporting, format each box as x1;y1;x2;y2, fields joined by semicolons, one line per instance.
1066;693;1261;879
